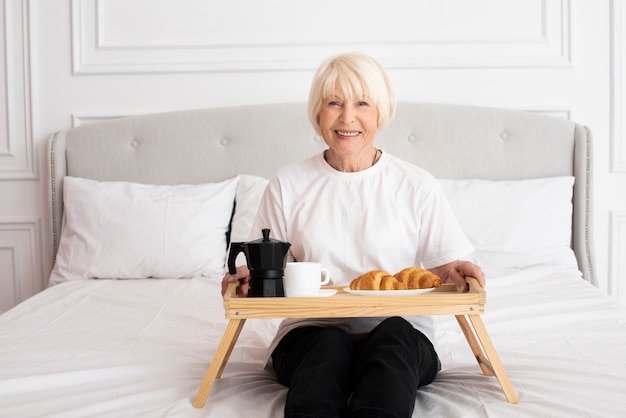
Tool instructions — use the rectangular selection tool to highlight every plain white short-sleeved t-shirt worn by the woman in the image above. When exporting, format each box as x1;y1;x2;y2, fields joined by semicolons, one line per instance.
251;152;473;366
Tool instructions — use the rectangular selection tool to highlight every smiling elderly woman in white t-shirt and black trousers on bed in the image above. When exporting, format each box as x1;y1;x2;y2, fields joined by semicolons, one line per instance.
223;53;485;418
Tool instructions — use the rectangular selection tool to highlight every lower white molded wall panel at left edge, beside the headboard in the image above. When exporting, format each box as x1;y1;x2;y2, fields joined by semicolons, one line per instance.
0;218;45;310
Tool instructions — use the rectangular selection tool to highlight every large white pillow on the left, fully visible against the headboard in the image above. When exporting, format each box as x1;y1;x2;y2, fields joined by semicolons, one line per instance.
50;177;239;285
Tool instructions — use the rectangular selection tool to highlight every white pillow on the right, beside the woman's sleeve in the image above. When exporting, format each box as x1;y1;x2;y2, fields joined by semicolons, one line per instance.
440;176;576;268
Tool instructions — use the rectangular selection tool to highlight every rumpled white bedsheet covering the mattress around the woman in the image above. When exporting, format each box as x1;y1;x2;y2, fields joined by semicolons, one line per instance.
0;267;626;418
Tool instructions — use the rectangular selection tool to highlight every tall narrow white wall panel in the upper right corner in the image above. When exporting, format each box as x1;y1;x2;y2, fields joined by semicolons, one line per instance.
610;0;626;173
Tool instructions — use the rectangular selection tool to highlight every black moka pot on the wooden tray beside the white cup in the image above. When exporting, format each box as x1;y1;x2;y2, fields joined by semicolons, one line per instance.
228;228;291;297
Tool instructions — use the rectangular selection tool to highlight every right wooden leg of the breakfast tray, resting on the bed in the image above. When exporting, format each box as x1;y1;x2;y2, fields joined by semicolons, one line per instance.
456;315;517;403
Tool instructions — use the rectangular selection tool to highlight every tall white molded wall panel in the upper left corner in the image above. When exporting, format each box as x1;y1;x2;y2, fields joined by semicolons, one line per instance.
0;0;39;180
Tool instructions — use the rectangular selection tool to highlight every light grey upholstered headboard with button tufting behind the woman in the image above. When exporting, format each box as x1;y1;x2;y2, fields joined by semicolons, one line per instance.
49;103;594;282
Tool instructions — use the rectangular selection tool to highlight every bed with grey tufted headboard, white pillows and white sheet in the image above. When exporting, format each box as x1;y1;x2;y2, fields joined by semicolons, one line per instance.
0;103;626;418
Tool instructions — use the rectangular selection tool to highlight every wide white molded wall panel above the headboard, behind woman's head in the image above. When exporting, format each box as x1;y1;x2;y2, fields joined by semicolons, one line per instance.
72;0;571;74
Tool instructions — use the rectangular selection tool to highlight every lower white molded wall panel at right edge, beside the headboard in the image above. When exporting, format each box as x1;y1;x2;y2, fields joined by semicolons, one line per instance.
608;211;626;301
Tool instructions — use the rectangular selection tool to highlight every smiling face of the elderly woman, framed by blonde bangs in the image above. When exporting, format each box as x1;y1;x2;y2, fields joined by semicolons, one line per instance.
318;91;378;159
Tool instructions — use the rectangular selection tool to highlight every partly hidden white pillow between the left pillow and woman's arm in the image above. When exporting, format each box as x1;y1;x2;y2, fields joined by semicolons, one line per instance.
230;174;268;242
